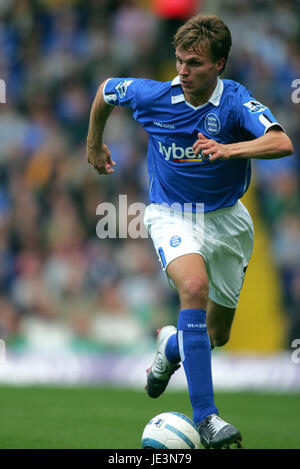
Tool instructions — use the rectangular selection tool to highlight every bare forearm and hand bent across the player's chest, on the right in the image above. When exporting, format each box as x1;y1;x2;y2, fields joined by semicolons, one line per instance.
193;126;294;161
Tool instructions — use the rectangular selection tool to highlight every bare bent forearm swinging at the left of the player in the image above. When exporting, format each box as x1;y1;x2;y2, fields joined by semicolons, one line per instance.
86;80;116;174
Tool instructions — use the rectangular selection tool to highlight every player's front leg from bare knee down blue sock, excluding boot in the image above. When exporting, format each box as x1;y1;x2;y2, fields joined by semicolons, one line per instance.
167;254;218;423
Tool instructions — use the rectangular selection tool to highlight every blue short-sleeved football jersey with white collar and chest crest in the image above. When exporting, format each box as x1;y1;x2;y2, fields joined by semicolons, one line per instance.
103;76;279;212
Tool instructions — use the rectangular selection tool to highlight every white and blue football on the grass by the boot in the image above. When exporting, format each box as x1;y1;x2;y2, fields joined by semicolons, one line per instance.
142;412;200;449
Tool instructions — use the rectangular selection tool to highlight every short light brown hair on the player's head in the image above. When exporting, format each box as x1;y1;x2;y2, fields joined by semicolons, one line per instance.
173;15;231;73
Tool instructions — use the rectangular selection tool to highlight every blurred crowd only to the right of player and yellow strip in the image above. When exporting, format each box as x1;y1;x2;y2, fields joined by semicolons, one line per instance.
220;0;300;347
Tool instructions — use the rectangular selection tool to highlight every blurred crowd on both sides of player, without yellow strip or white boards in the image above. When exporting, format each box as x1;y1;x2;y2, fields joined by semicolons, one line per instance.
0;0;300;350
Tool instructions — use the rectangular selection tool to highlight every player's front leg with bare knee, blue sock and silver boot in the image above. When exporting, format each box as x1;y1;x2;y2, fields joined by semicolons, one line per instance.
167;254;241;448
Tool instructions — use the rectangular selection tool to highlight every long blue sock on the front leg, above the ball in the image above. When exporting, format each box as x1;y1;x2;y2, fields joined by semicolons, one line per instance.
177;309;218;424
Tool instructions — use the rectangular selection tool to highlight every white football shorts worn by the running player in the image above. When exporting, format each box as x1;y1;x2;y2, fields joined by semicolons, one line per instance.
144;201;254;308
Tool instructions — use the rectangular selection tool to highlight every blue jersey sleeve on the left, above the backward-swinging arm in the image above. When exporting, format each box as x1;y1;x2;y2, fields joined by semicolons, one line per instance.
103;78;139;110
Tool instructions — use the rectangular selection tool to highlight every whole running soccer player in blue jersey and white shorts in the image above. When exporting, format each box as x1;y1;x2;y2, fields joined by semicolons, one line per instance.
87;15;293;448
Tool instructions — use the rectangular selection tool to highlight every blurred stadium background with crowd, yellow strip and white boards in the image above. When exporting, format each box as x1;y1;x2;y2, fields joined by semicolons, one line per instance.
0;0;300;448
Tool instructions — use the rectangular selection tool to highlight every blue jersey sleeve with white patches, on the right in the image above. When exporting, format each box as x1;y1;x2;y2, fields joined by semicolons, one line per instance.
238;90;284;138
